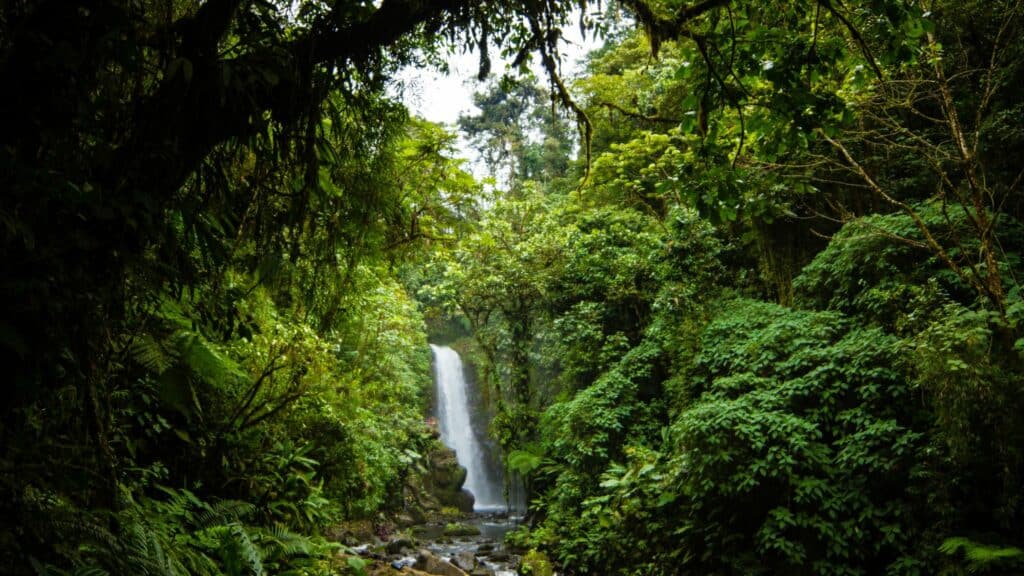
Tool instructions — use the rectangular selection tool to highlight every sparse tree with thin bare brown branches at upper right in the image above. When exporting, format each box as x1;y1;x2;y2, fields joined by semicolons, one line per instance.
822;1;1024;320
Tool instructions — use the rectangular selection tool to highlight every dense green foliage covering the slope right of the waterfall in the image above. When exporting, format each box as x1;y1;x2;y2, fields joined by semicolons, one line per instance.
419;2;1024;575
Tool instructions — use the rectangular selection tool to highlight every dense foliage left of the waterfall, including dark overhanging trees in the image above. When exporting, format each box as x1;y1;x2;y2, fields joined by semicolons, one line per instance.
0;0;581;574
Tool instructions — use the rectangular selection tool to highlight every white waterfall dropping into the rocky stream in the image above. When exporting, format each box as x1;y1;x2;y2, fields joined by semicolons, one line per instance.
430;344;505;511
